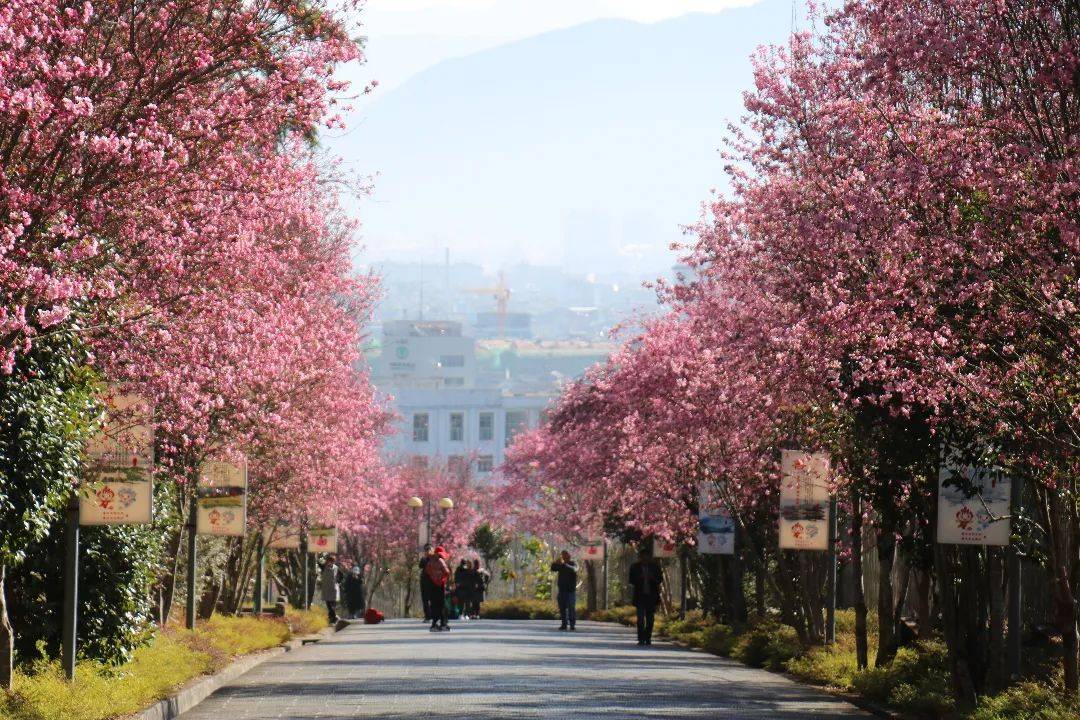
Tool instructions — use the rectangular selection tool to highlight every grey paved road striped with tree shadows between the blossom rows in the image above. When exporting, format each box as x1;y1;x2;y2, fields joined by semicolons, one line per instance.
181;621;870;720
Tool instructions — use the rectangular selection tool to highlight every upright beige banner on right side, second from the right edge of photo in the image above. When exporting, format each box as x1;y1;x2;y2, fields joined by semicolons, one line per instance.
780;450;829;551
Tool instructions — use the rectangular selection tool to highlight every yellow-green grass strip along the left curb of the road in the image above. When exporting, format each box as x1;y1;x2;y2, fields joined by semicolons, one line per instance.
0;611;326;720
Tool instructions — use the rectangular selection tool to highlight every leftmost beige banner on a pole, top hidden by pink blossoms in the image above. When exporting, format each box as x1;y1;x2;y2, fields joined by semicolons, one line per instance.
79;395;153;525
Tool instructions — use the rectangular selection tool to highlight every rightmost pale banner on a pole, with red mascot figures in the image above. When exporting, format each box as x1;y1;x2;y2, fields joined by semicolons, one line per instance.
937;464;1012;545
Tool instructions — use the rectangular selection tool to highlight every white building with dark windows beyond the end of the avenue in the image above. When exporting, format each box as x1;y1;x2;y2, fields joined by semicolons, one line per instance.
372;321;551;476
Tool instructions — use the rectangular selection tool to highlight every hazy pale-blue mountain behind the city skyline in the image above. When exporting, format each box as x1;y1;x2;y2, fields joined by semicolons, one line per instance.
328;0;791;272
